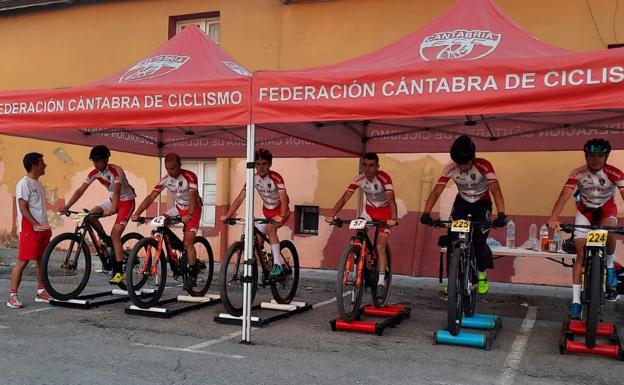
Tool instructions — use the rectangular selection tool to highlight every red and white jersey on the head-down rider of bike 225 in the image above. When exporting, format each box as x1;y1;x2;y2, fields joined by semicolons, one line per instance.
437;158;496;203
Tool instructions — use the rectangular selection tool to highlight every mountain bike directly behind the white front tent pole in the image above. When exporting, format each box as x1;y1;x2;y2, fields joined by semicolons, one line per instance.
219;218;299;317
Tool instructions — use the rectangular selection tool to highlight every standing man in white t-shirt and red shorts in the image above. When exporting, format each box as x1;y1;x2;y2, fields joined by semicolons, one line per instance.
7;152;52;309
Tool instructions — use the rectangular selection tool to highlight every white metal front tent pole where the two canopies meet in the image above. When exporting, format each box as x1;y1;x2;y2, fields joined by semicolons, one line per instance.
241;124;256;344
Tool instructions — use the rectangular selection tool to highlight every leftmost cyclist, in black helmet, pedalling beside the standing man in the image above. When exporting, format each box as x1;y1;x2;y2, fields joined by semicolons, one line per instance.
59;145;136;284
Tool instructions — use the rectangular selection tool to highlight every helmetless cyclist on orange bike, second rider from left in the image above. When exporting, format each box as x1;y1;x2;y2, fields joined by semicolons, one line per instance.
130;153;202;290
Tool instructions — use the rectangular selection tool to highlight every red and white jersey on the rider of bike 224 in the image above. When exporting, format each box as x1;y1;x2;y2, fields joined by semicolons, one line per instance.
565;164;624;208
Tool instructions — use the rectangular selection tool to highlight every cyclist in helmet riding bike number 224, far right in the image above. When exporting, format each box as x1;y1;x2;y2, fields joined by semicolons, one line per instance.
548;139;624;319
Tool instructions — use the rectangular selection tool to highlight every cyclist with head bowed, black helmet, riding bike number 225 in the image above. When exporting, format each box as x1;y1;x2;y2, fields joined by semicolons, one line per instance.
420;135;507;294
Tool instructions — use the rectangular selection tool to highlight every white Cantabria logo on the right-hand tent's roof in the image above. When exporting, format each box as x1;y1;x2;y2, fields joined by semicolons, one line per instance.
420;29;501;61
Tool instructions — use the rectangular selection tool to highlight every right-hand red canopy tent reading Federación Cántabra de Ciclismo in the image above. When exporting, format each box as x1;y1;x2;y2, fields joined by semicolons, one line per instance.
253;0;624;156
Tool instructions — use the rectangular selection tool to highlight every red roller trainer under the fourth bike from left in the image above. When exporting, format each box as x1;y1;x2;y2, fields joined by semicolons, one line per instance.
329;305;411;336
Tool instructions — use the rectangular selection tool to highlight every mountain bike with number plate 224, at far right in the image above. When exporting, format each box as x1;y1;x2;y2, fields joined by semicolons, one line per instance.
559;224;624;349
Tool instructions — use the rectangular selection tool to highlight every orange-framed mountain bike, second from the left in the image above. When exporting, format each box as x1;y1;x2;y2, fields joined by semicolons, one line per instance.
126;216;214;309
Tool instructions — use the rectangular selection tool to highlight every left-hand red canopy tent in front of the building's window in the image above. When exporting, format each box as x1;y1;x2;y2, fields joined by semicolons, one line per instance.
0;26;342;157
